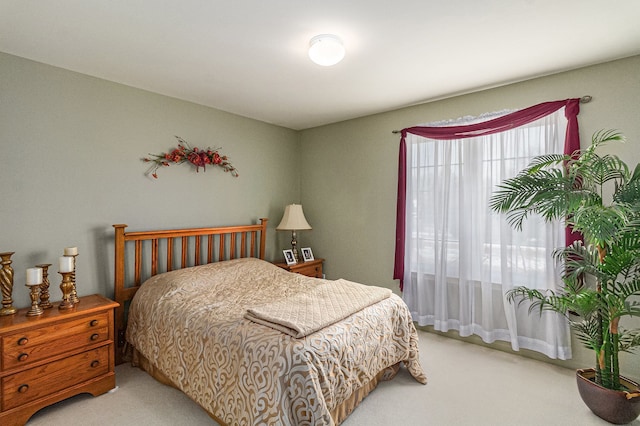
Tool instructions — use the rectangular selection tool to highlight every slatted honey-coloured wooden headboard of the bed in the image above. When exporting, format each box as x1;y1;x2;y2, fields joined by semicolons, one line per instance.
113;219;267;364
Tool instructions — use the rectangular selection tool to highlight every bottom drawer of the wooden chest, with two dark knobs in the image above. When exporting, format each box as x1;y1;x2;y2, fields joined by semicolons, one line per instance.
2;345;111;411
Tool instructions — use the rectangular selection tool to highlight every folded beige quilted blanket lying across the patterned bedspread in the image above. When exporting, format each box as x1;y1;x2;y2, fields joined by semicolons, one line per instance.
244;279;391;338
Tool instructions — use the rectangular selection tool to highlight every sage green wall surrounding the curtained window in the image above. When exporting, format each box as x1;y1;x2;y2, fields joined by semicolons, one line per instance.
300;56;640;378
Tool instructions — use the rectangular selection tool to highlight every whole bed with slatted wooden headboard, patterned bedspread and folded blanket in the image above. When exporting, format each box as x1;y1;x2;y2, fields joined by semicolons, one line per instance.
114;219;426;425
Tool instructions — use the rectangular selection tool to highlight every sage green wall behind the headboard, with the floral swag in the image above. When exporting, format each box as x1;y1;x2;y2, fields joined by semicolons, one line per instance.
0;53;300;307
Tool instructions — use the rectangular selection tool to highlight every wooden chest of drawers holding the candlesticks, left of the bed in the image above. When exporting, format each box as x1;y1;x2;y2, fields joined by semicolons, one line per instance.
0;295;118;426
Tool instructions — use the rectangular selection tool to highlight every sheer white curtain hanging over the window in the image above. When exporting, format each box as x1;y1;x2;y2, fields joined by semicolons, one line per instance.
403;108;571;359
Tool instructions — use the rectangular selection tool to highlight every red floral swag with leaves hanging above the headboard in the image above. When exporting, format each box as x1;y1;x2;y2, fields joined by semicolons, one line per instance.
142;136;238;179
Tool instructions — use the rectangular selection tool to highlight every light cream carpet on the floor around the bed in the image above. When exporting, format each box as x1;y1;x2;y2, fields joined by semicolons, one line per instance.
27;331;640;426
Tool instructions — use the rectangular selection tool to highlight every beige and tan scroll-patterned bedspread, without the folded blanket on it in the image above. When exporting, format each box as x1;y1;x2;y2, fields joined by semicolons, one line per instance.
127;259;426;425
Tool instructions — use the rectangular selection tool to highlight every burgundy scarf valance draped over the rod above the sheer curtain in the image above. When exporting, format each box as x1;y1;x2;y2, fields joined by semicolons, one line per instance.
393;98;580;289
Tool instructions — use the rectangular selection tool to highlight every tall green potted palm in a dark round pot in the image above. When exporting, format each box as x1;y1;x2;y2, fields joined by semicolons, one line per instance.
490;130;640;424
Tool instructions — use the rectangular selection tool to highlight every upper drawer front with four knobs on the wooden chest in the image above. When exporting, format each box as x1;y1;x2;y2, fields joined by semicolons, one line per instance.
2;313;109;371
